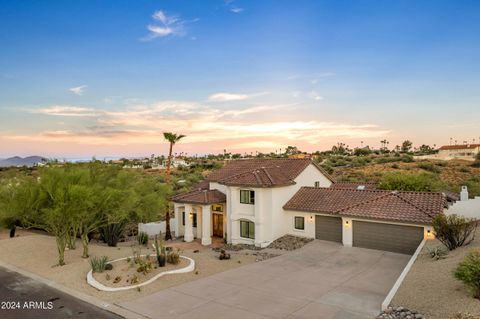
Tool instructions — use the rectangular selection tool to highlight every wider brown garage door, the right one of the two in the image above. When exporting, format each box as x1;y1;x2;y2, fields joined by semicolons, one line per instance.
353;220;423;255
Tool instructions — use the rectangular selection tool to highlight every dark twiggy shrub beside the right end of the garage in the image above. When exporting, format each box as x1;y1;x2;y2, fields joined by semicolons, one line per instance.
433;214;477;250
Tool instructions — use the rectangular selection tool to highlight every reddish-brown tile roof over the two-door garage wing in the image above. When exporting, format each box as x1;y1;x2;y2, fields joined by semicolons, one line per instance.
283;187;445;224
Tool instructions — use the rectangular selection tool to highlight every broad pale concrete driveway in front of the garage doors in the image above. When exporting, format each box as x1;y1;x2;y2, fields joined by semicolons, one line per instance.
120;240;410;319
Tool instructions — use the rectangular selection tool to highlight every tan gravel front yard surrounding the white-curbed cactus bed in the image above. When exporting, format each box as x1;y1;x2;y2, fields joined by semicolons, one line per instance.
0;234;255;302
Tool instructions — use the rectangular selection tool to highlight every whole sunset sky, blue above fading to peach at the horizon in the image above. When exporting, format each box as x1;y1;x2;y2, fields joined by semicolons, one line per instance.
0;0;480;158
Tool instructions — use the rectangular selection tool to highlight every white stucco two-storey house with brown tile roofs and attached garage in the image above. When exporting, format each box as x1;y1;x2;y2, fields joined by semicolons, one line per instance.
173;158;445;253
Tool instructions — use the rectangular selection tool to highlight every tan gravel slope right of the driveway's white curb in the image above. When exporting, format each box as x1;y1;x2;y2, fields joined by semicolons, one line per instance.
392;231;480;319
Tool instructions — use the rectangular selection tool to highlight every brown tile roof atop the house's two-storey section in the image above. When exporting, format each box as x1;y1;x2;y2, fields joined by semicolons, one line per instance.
207;158;333;187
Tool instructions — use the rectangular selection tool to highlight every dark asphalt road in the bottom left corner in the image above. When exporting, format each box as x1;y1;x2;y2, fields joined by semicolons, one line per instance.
0;267;122;319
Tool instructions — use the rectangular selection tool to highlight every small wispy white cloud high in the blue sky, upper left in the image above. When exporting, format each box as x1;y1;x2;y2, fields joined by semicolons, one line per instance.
143;10;193;41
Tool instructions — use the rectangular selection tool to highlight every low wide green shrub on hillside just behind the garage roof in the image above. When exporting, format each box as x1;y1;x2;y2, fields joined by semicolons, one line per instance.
378;172;441;192
